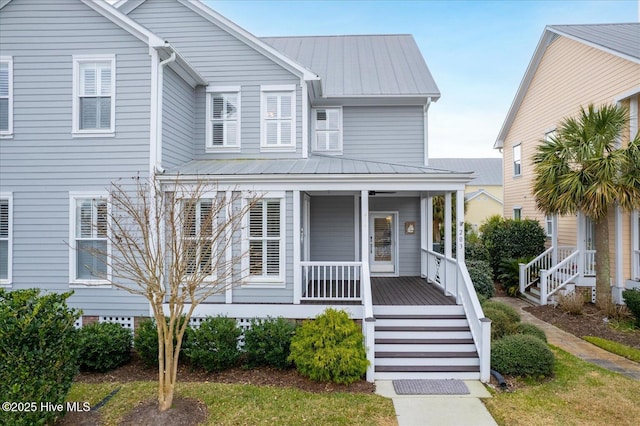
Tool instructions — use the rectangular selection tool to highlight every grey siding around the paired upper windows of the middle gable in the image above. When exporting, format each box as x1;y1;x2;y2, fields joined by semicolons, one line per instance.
129;0;306;159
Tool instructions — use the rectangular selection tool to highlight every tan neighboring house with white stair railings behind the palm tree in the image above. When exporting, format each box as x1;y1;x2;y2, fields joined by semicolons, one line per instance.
494;23;640;303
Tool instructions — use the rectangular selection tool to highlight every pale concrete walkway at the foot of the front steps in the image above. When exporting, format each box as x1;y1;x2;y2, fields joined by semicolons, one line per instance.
376;380;497;426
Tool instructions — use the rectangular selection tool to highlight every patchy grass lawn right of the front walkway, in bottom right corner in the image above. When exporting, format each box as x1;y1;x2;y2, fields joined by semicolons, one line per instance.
484;346;640;426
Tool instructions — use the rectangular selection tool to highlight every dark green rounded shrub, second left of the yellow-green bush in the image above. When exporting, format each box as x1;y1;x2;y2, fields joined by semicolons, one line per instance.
184;316;242;372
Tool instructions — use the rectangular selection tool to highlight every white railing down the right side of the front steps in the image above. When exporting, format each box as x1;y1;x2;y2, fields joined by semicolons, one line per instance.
422;249;491;383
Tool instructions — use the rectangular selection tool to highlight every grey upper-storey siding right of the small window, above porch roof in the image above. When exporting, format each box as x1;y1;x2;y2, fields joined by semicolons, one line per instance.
342;106;424;165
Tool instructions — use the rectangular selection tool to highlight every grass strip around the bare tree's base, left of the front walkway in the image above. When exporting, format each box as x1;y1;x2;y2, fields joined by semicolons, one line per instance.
67;382;397;426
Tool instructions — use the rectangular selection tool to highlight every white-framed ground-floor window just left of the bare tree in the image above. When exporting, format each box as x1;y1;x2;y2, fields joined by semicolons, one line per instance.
70;195;109;284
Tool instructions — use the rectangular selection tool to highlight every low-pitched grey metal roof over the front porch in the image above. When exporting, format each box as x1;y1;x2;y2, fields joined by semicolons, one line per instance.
165;155;472;180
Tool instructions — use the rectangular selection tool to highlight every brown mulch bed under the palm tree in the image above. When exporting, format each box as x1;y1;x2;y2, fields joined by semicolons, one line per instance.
524;303;640;350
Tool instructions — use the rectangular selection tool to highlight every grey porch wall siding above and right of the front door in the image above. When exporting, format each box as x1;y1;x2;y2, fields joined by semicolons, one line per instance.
369;196;421;276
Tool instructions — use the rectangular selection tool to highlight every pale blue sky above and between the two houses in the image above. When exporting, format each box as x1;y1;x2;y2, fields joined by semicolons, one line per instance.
205;0;640;157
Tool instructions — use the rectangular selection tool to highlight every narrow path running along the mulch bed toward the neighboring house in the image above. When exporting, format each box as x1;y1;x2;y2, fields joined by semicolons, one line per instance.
492;297;640;380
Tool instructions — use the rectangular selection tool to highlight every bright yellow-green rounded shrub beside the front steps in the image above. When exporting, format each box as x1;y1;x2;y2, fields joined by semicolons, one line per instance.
289;308;369;384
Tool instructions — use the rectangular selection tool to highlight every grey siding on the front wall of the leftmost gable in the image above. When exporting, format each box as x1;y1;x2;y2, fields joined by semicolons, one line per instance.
0;0;151;315
